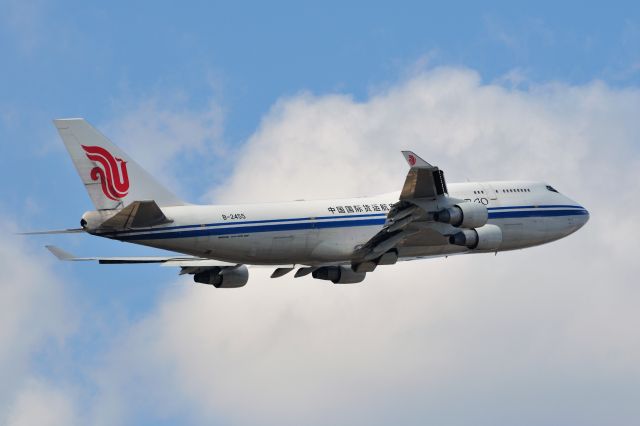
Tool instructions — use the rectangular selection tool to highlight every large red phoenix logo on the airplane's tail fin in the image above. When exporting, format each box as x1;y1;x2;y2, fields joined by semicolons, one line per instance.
82;145;129;201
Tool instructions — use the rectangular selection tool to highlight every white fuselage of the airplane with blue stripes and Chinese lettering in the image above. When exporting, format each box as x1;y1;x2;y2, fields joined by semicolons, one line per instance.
98;181;589;265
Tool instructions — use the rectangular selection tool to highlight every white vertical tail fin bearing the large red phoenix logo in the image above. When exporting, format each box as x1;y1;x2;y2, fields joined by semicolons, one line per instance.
53;118;185;210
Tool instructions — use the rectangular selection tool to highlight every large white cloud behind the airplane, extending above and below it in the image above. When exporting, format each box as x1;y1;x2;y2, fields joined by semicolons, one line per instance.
87;69;640;424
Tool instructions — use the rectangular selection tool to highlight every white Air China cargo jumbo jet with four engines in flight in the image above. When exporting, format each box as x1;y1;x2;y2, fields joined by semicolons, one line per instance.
27;118;589;288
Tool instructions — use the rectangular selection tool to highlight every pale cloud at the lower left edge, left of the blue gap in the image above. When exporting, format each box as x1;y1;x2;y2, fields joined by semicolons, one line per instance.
0;225;78;424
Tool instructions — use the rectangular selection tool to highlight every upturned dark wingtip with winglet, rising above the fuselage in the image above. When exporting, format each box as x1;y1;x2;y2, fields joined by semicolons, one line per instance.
400;151;448;200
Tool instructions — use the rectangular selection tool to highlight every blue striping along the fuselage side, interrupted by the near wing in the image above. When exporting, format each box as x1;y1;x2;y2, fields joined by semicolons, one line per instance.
111;206;589;241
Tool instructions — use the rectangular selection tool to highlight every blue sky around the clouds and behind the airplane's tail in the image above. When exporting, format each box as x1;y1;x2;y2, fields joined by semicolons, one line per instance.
0;0;640;424
